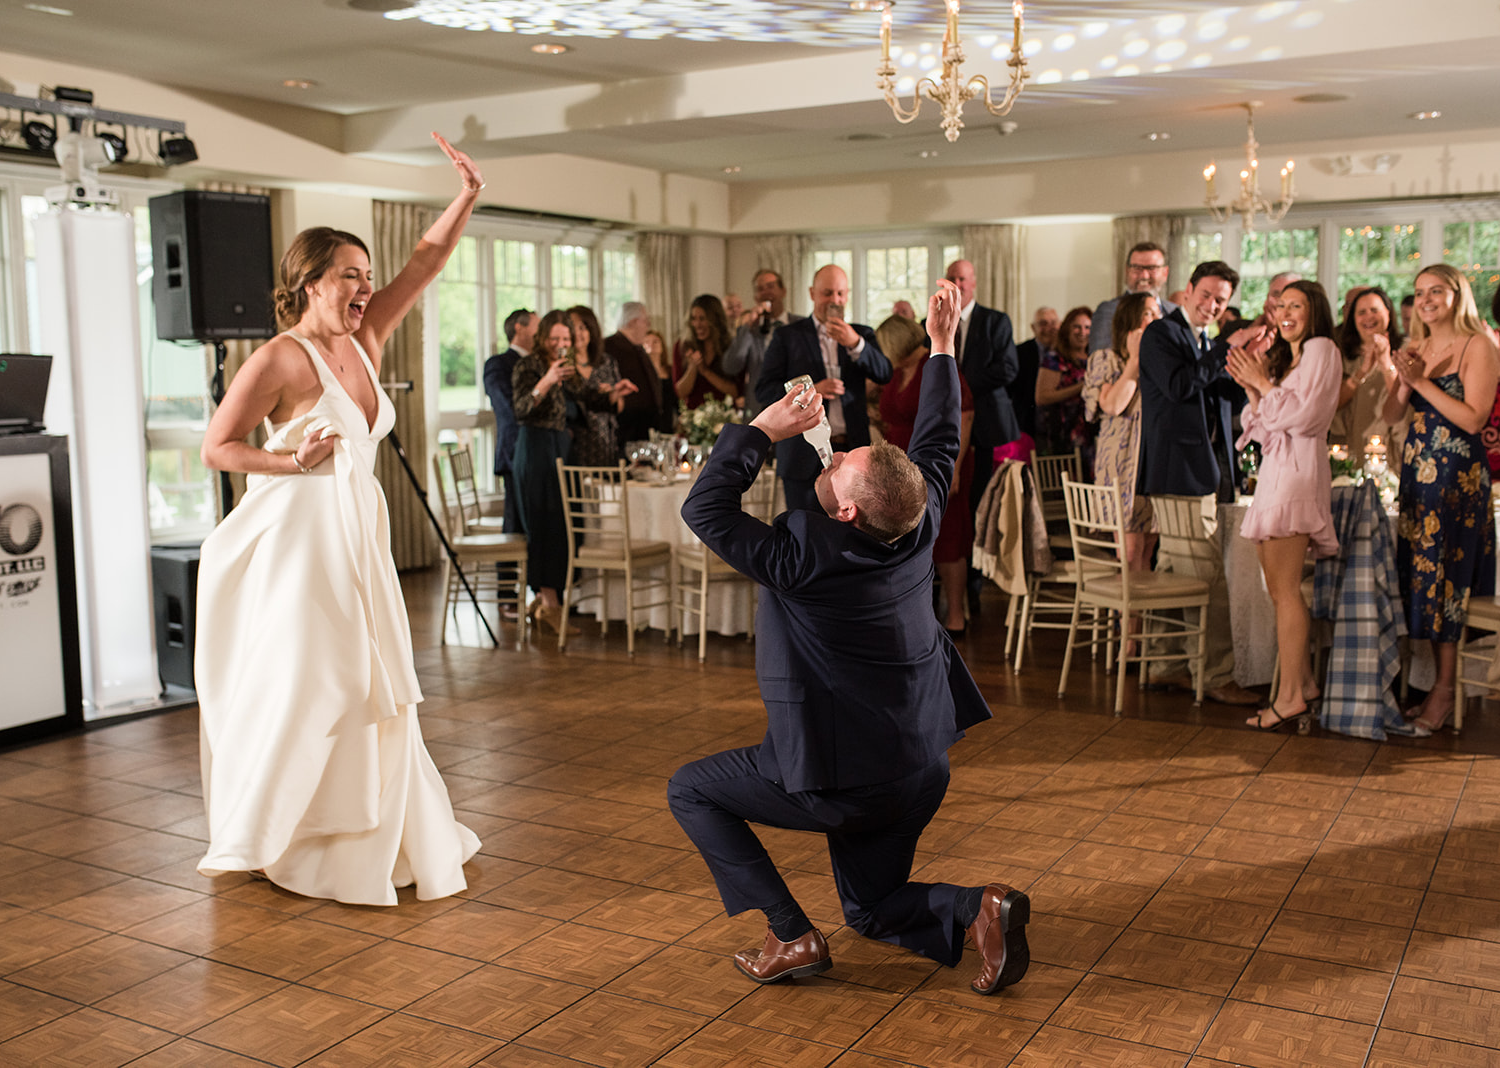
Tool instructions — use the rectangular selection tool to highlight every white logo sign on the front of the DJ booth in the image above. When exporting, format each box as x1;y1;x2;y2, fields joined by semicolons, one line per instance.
0;453;68;731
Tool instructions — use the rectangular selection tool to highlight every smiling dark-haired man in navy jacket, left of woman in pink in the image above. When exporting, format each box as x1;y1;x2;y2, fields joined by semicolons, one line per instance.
1136;260;1260;705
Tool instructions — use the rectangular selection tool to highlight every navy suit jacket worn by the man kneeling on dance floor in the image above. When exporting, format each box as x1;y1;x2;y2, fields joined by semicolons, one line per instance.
683;352;990;792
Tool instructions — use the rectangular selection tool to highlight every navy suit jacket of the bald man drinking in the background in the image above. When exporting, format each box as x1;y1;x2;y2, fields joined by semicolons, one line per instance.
756;317;891;483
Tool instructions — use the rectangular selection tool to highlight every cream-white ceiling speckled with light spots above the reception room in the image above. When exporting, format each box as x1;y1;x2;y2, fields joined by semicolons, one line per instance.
0;0;1500;182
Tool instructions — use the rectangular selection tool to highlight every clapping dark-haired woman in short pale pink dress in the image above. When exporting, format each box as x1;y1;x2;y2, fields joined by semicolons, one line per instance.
1229;282;1344;731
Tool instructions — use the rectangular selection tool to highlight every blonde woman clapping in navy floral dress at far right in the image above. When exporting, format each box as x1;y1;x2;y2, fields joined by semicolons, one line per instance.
1383;264;1500;738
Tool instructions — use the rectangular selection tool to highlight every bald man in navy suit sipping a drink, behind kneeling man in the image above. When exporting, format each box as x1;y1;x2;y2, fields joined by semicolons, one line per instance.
755;264;891;510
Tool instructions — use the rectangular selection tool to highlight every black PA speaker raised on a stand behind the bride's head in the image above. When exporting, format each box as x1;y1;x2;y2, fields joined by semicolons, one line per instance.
150;189;276;341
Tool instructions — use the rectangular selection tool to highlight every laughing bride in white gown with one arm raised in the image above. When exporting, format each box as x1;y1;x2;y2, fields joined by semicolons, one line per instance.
195;134;485;905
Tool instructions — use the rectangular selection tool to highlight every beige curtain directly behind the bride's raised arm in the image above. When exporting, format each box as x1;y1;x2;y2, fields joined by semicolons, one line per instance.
371;201;440;569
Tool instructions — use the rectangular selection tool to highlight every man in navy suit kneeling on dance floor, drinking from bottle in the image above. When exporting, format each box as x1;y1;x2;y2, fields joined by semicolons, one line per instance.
668;282;1031;995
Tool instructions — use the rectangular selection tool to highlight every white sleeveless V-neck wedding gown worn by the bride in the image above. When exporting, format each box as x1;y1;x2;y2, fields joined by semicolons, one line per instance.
195;333;479;905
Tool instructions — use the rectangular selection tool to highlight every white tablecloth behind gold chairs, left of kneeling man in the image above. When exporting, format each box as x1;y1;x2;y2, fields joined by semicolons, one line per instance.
576;477;756;635
